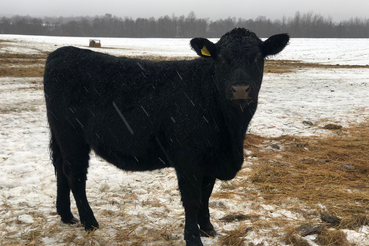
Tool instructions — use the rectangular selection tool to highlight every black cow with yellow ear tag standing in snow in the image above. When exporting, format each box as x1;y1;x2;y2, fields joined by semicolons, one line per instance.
44;28;289;245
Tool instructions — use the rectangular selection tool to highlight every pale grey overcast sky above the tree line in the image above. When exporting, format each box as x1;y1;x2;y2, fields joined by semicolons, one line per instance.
0;0;369;21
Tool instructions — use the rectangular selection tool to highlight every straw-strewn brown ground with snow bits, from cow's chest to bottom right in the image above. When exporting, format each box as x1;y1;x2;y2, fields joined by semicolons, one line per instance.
212;122;369;246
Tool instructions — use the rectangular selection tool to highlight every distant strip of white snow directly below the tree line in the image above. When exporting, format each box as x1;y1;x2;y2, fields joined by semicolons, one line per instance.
0;35;369;65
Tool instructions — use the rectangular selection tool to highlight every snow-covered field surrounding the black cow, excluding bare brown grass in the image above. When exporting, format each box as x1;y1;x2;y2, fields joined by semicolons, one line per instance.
0;35;369;246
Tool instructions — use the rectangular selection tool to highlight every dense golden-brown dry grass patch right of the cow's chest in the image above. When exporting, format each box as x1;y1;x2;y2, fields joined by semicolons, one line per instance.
245;124;369;216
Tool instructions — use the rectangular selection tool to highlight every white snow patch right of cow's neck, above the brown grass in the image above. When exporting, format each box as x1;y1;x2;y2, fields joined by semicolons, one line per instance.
249;68;369;137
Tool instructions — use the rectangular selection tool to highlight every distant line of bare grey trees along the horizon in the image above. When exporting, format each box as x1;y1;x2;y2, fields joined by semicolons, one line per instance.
0;12;369;38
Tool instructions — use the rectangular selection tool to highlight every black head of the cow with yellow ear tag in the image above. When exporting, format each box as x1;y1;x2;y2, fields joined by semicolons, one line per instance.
191;28;289;108
